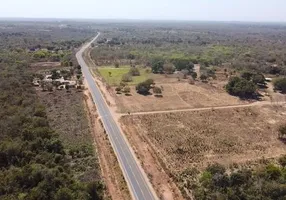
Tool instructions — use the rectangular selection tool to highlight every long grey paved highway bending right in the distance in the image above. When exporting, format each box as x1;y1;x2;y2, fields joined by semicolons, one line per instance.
76;33;158;200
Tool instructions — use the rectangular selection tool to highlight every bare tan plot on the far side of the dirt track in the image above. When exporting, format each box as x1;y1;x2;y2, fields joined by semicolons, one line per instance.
113;82;244;112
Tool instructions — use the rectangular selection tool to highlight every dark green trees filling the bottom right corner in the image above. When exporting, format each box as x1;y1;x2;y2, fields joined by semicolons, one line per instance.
192;161;286;199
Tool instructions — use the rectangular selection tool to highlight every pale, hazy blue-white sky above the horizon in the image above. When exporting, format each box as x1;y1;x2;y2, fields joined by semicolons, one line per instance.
0;0;286;22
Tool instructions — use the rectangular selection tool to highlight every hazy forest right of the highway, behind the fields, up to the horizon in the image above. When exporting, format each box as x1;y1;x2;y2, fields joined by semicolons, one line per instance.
92;22;286;74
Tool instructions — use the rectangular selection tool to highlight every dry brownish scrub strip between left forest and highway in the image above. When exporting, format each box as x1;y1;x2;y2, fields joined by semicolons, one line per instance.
38;91;100;184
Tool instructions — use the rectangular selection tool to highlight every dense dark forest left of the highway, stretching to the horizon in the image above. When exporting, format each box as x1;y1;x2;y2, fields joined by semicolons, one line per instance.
0;22;104;200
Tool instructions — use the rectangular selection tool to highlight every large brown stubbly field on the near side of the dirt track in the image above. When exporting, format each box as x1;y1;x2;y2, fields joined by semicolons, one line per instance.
121;105;286;175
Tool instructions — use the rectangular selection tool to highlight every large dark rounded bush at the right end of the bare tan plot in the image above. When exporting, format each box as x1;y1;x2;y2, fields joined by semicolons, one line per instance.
225;77;256;98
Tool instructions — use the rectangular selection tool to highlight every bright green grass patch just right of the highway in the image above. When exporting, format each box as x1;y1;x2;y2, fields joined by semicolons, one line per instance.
98;66;151;86
